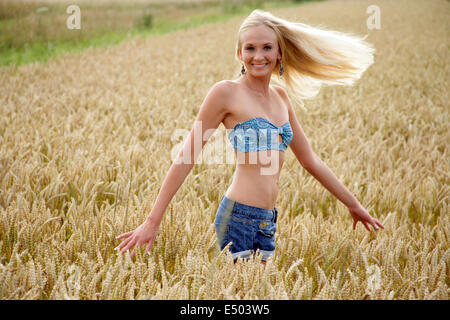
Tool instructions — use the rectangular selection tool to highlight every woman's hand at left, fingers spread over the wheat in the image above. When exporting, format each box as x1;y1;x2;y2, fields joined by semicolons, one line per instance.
114;216;159;258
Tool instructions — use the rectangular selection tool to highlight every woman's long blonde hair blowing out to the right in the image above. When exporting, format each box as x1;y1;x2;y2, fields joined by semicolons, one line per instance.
235;9;375;105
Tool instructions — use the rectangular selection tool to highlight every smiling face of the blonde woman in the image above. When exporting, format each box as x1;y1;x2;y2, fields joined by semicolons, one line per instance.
239;24;281;77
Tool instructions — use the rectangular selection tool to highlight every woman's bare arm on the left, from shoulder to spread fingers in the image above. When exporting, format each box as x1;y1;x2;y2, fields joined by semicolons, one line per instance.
116;80;230;257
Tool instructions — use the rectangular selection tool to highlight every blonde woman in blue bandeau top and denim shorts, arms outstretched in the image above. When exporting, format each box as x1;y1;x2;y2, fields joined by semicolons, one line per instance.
116;10;384;263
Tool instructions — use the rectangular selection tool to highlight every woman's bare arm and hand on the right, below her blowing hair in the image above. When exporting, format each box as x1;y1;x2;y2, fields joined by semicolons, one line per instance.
277;87;384;231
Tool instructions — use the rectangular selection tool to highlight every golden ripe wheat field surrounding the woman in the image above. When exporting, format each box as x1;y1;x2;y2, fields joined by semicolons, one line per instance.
0;0;450;300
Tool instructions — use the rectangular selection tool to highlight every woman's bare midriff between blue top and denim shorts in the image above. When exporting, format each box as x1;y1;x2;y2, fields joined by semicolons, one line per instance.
225;144;285;209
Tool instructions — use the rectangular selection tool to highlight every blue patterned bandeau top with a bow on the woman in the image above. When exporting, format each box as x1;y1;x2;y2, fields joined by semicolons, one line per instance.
228;117;294;152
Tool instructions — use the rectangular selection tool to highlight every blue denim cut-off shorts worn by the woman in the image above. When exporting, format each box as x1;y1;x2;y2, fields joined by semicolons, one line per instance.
214;195;278;261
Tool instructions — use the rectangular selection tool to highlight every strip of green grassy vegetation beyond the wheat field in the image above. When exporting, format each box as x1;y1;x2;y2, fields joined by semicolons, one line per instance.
0;0;320;66
